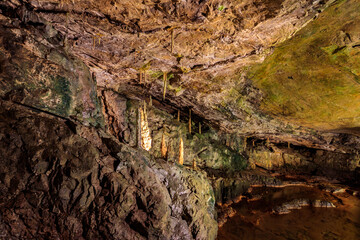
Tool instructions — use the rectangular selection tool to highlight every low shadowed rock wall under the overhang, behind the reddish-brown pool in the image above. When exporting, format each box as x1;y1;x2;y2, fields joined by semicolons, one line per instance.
246;141;360;184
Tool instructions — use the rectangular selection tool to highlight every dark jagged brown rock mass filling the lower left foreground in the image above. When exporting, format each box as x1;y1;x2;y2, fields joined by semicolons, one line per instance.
0;101;217;239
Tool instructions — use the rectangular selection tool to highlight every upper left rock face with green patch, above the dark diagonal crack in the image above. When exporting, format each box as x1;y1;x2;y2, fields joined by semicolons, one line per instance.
0;9;103;126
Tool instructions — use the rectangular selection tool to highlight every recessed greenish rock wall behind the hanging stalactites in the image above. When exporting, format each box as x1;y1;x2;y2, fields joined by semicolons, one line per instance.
101;90;247;170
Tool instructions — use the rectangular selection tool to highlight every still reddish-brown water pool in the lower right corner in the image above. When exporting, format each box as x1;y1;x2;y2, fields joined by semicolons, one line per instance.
218;187;360;240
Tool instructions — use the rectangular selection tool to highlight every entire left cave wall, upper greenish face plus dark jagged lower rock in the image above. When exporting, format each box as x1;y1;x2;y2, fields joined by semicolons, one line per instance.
0;5;217;239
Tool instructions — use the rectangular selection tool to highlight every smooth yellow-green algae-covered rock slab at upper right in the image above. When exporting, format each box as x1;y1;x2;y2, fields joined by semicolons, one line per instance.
248;1;360;130
